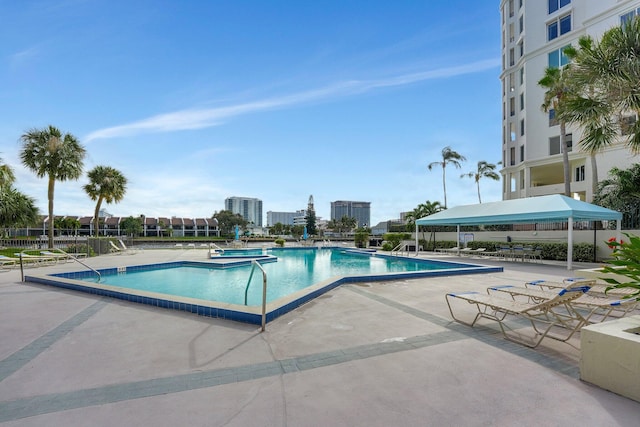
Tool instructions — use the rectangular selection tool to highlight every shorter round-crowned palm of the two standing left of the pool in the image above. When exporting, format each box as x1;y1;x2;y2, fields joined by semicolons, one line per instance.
82;166;127;235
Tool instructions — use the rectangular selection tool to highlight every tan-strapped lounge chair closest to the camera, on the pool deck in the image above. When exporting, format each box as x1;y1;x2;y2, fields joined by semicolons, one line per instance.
445;282;589;348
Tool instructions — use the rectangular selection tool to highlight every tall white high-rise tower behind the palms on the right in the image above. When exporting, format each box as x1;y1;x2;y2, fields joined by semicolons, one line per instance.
500;0;640;202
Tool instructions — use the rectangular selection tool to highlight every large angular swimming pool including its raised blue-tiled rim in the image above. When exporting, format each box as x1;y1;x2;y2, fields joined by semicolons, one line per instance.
25;248;502;324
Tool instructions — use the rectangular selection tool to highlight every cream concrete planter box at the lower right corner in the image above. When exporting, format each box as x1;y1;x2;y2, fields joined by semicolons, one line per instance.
580;316;640;402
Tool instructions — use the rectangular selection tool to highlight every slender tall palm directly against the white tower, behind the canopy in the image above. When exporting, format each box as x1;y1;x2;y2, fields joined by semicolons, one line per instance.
538;65;571;197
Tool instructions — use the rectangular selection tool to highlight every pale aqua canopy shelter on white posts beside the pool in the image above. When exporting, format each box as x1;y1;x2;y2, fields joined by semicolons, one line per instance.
416;194;622;270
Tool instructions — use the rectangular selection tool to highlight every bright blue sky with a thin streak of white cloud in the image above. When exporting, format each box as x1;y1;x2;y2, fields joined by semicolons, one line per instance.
0;0;501;224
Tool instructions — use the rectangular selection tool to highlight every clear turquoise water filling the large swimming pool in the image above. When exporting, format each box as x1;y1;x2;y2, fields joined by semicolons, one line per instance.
92;249;452;306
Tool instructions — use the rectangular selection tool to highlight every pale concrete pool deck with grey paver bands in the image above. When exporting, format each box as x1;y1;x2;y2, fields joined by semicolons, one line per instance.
0;249;640;426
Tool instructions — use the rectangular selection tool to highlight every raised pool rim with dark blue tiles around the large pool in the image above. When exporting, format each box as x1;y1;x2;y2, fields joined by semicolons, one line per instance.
24;261;503;325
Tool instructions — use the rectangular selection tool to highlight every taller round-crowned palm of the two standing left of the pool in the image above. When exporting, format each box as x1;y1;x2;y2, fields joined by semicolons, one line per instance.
20;125;85;248
